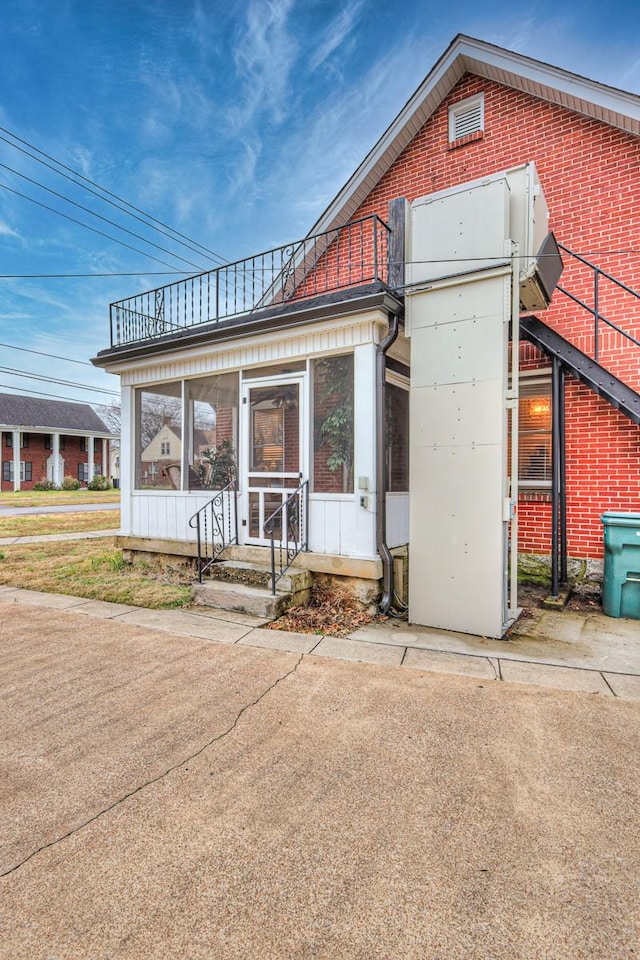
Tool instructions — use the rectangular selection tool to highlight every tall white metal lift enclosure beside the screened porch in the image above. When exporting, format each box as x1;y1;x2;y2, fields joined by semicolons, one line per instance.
406;164;546;637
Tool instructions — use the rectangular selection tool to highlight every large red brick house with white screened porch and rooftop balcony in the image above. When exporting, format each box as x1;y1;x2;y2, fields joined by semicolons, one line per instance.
94;36;640;636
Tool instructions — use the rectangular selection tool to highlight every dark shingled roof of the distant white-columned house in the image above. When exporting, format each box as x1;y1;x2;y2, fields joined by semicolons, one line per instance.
0;393;112;437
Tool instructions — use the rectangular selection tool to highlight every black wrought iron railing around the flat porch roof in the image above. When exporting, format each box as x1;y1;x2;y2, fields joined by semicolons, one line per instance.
110;214;390;346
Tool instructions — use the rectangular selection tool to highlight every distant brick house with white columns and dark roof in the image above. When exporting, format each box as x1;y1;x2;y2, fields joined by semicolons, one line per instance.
0;393;112;491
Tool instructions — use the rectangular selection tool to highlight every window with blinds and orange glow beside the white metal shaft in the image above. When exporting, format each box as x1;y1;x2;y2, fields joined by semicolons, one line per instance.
518;377;551;487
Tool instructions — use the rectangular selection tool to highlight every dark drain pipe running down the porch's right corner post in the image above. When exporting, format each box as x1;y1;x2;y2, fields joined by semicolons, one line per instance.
376;314;400;613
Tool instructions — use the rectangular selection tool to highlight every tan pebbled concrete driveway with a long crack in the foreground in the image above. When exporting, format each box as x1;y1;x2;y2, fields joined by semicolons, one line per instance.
0;603;640;960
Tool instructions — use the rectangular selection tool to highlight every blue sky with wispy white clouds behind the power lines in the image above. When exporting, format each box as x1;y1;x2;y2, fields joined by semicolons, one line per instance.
0;0;640;403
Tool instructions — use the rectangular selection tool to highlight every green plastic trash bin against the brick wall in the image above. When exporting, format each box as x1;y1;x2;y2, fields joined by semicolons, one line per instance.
602;511;640;620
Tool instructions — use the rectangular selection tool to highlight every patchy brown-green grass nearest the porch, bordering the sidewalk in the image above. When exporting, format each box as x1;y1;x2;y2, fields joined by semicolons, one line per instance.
0;537;194;609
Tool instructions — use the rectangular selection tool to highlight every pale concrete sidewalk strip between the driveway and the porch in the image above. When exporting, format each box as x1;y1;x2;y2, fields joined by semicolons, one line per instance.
0;587;640;699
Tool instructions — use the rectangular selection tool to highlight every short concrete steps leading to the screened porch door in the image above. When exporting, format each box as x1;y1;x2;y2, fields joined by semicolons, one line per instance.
194;560;312;621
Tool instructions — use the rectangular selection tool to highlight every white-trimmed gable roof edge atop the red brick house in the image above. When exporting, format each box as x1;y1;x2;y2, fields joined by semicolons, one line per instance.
309;34;640;236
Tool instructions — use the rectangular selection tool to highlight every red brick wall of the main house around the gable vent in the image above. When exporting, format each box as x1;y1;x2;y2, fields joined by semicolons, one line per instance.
354;75;640;557
